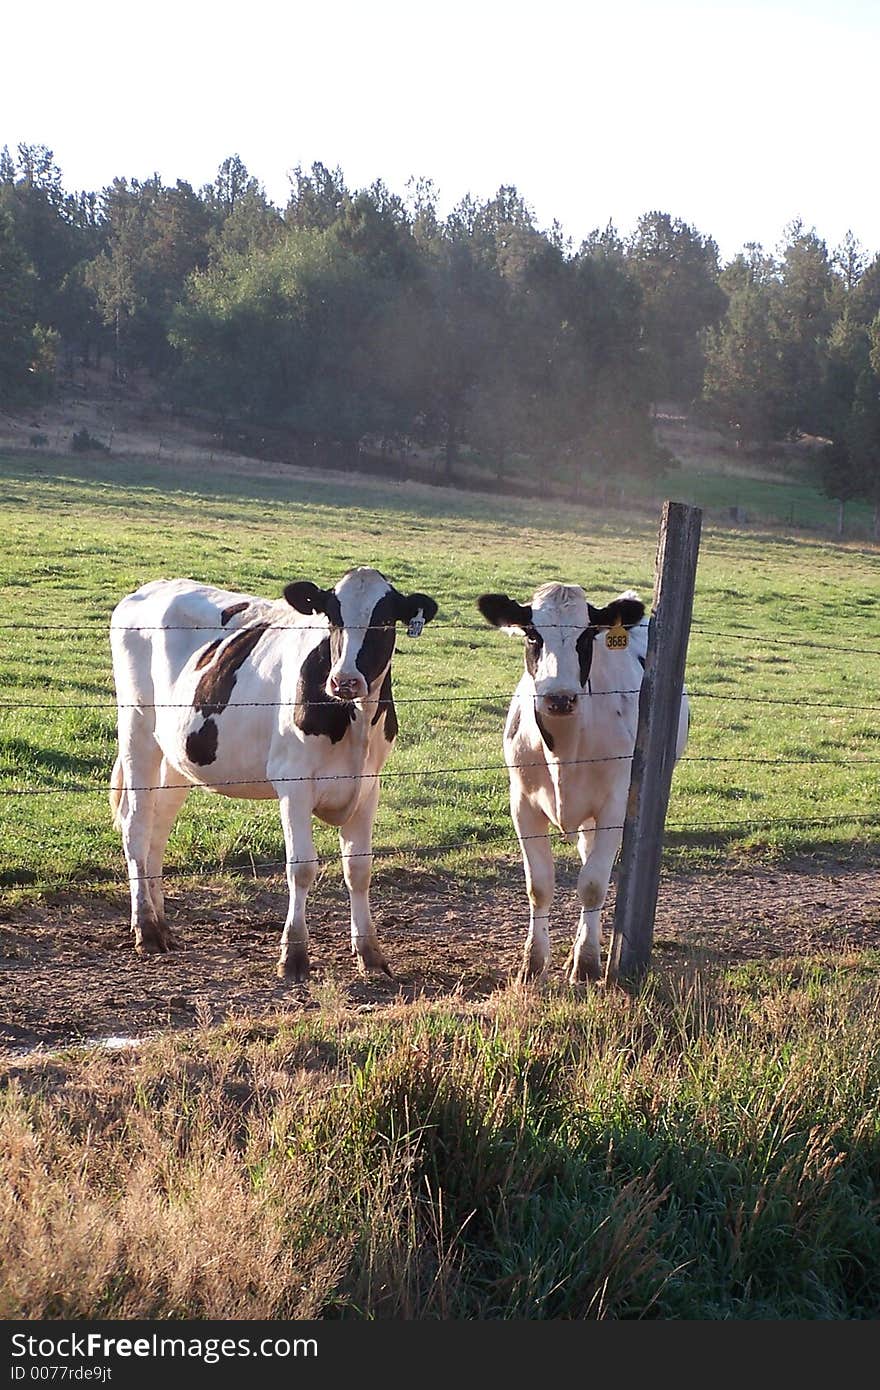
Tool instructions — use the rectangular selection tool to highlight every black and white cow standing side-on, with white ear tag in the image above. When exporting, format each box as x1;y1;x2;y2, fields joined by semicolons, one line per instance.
110;567;437;980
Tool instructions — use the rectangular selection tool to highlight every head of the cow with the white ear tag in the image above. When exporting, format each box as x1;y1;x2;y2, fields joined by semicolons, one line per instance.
284;566;437;701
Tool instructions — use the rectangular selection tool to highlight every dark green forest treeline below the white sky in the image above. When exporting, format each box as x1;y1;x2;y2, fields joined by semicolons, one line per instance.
0;145;880;506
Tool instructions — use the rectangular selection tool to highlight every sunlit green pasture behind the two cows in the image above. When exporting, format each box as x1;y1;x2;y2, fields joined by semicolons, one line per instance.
0;457;880;891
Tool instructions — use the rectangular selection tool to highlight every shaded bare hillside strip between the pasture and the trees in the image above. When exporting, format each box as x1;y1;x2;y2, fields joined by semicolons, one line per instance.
0;368;877;539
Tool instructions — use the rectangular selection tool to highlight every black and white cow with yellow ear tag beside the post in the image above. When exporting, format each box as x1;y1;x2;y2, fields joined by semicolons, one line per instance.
477;584;688;984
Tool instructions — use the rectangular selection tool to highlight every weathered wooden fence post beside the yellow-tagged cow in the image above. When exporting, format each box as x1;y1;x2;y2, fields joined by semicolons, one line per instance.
605;502;702;984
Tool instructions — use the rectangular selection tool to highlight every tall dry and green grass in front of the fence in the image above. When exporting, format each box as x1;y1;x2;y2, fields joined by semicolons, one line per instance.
0;956;880;1319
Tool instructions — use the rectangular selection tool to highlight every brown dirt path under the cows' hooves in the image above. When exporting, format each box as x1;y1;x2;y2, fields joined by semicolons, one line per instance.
0;865;880;1049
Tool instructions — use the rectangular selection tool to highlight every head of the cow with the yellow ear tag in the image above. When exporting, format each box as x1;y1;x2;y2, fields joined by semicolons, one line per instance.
477;584;645;716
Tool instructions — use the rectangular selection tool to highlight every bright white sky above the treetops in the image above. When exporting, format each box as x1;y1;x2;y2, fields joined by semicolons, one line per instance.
0;0;880;259
